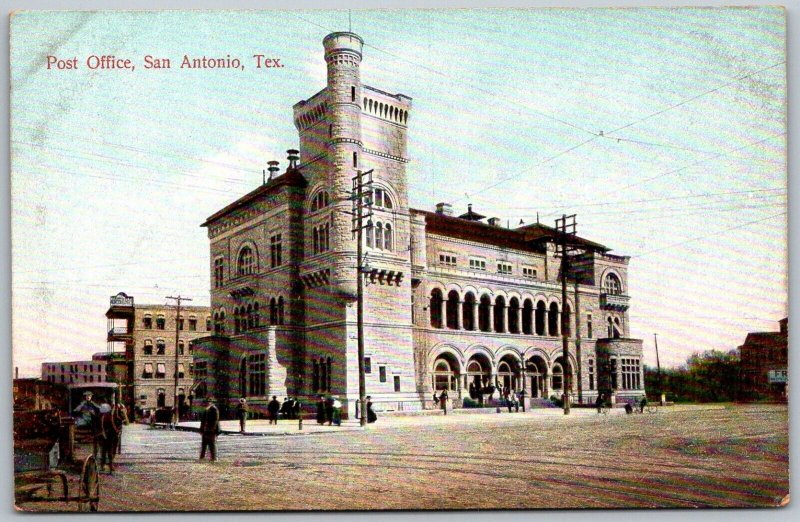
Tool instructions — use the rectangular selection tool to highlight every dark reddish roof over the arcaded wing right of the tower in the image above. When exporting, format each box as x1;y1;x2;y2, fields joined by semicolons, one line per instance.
411;209;609;252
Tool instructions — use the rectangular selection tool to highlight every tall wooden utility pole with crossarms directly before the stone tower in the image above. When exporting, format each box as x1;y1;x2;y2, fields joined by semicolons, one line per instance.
350;169;373;426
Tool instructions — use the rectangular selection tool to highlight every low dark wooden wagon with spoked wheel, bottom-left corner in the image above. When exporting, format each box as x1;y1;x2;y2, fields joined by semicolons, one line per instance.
14;455;100;511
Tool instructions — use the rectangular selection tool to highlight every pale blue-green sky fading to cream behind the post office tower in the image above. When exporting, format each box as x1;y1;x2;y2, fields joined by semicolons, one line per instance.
11;8;788;376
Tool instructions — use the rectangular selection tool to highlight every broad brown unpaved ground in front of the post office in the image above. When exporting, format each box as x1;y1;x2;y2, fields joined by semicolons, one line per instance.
20;406;789;511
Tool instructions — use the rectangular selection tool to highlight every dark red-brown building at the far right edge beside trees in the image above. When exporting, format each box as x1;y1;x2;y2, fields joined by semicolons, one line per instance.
739;317;789;401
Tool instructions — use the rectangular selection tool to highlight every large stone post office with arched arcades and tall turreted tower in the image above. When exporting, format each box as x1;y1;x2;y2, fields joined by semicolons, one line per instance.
195;33;644;414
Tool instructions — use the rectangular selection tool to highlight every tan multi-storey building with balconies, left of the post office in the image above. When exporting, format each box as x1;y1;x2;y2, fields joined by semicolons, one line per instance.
106;292;211;412
